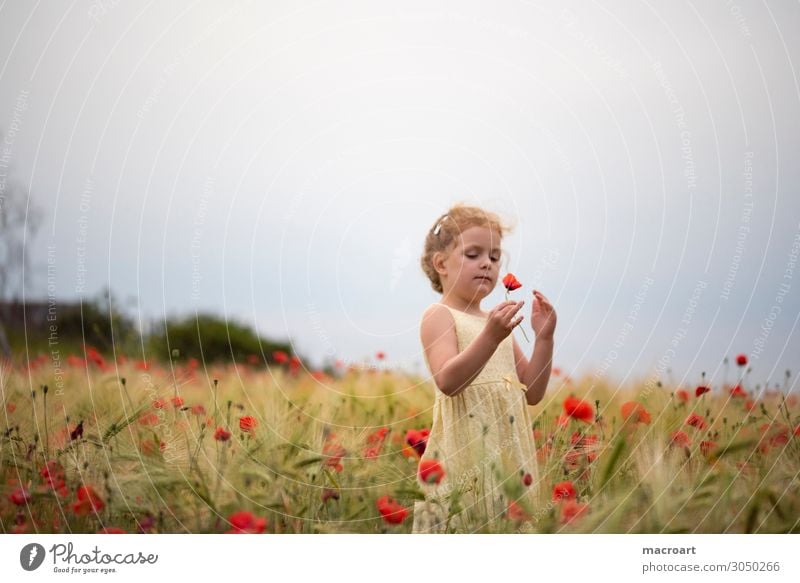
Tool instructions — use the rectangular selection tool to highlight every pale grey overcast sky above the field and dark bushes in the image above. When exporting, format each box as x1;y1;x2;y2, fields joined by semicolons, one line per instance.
0;0;800;392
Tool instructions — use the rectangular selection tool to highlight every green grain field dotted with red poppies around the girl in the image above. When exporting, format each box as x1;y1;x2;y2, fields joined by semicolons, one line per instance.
0;348;800;534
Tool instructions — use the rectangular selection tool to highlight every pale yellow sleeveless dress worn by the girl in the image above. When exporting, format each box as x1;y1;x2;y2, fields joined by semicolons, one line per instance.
412;304;539;533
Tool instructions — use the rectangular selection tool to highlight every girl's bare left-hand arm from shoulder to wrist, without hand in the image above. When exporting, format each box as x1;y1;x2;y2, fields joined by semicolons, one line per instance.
420;305;497;397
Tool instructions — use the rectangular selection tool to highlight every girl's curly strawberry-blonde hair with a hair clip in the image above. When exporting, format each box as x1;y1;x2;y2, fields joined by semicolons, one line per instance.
420;203;513;293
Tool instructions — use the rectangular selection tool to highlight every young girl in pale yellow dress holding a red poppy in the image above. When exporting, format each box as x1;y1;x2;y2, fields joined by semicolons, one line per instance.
412;204;556;533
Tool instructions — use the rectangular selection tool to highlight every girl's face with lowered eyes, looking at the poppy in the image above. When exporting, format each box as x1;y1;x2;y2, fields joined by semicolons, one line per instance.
434;227;502;303
